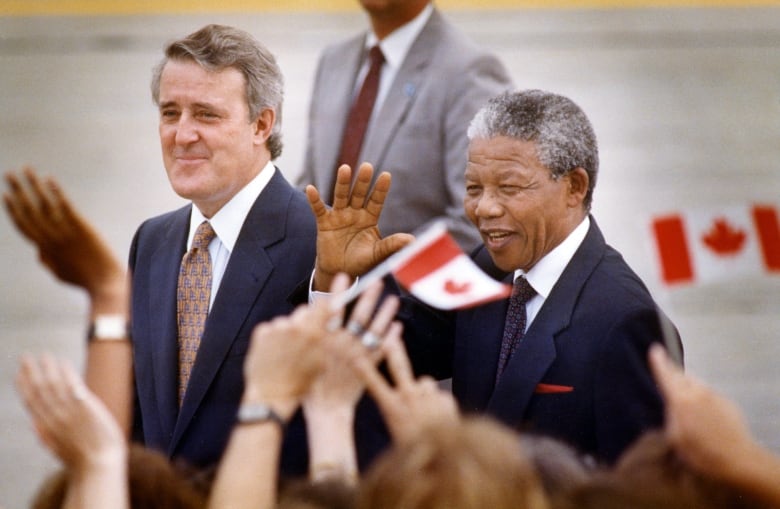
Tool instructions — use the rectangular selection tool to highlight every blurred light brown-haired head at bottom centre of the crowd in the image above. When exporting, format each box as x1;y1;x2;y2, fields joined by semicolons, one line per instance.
356;417;548;509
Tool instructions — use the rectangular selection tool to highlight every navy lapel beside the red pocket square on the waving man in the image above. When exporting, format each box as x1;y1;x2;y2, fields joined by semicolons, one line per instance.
488;217;606;423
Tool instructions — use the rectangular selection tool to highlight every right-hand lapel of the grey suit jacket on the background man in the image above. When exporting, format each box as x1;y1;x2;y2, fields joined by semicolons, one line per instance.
360;11;443;171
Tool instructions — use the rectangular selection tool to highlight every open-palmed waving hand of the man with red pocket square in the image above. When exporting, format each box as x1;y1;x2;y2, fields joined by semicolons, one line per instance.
306;163;414;291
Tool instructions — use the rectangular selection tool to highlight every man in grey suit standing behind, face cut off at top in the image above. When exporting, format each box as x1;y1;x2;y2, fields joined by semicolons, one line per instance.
297;0;512;250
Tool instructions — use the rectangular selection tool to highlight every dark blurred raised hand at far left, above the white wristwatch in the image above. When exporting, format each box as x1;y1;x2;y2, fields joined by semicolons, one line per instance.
3;167;126;301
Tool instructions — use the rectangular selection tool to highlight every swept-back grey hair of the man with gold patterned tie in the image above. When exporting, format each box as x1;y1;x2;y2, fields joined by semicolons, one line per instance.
152;25;284;159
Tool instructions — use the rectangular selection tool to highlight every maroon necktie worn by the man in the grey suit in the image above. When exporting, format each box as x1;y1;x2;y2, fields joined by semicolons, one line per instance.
331;46;385;201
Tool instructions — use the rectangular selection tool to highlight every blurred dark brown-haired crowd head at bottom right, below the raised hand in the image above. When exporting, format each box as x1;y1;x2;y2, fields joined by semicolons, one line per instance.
556;431;767;509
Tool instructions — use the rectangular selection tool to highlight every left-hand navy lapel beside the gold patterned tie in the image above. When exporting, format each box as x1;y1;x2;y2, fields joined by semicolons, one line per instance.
148;206;190;433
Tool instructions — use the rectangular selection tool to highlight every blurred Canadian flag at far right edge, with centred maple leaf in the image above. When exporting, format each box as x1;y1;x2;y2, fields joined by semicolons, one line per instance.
652;205;780;284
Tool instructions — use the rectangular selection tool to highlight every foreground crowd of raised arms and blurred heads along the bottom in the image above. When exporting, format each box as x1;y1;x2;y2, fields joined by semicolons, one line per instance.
4;169;780;509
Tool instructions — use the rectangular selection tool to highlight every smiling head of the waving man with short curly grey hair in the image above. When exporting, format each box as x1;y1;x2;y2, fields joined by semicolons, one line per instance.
463;90;599;272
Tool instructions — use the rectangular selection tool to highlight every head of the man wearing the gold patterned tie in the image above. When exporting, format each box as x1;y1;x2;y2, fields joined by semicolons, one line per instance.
152;25;284;217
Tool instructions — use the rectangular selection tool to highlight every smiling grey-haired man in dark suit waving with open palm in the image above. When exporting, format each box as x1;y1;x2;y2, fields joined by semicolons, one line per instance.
307;90;679;462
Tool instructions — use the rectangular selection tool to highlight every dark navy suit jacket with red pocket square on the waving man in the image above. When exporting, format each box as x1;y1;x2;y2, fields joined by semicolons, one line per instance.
402;218;679;462
